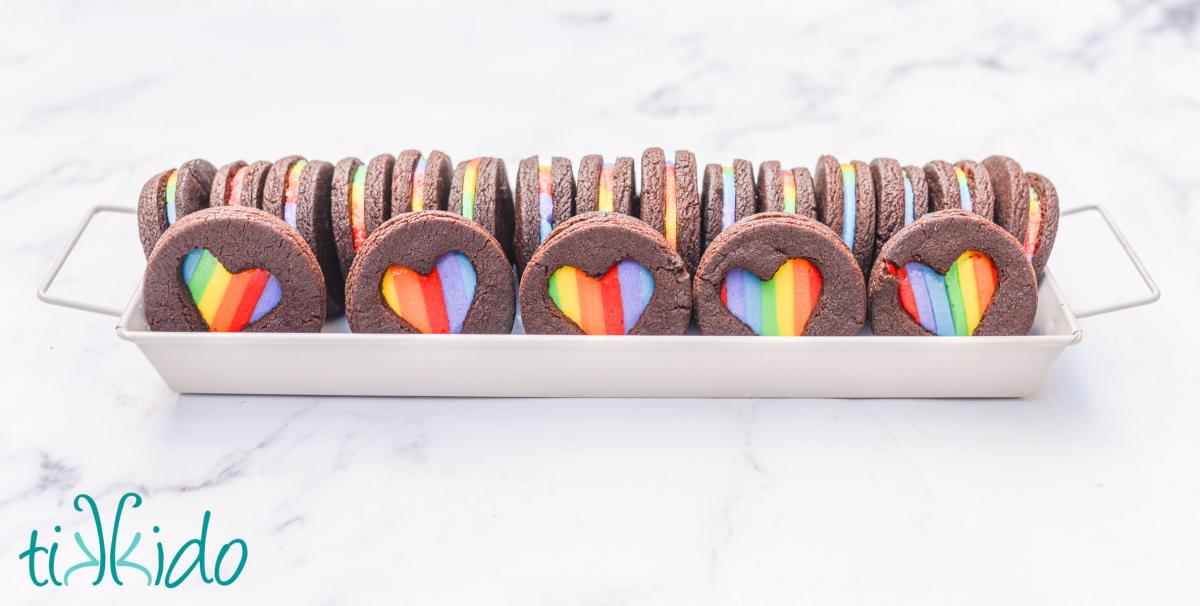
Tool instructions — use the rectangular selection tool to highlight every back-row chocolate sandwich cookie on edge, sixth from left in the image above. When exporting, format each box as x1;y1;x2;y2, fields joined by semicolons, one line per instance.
448;157;515;262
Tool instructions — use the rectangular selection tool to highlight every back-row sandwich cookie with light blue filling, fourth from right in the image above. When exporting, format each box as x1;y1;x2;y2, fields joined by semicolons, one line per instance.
814;156;875;274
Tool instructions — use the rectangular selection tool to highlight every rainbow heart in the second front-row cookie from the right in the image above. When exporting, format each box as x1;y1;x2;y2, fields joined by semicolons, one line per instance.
721;258;821;337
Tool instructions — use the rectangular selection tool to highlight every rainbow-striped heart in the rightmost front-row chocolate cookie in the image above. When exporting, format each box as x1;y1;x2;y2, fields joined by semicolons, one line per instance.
888;251;997;337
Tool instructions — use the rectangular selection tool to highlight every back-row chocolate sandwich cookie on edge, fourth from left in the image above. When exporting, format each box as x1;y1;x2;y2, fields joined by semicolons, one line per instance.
330;154;395;276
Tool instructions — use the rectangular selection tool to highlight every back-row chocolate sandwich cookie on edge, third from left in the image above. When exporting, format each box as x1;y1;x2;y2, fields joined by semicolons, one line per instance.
263;156;346;316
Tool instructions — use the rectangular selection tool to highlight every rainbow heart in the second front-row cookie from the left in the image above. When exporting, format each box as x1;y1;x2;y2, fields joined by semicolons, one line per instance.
379;252;476;335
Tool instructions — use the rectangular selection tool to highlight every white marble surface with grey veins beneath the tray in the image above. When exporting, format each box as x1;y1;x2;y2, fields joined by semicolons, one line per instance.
0;1;1200;605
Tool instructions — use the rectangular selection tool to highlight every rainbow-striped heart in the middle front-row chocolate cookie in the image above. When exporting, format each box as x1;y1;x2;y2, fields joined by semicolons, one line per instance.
547;259;654;335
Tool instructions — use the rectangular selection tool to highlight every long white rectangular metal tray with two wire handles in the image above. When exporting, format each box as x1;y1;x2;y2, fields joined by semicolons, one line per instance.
38;206;1159;397
